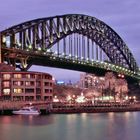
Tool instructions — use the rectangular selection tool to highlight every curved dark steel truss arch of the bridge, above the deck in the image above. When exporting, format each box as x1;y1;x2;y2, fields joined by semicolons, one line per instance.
1;14;138;72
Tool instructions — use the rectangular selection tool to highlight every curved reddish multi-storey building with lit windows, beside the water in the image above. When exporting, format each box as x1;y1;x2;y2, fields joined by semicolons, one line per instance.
0;71;53;101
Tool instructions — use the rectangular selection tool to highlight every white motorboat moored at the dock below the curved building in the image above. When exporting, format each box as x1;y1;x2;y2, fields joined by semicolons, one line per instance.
12;106;40;115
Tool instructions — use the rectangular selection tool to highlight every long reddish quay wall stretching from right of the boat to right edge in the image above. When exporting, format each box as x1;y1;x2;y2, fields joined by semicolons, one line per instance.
51;104;140;113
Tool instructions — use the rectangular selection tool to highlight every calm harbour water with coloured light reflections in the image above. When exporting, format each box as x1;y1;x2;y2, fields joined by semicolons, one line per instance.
0;112;140;140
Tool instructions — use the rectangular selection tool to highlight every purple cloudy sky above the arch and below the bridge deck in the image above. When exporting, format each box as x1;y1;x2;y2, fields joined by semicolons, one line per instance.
0;0;140;81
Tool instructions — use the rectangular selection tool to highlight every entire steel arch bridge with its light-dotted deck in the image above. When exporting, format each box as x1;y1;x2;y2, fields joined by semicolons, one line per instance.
0;14;140;79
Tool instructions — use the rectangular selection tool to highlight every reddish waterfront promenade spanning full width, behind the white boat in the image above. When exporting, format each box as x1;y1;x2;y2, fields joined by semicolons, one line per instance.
0;101;140;114
